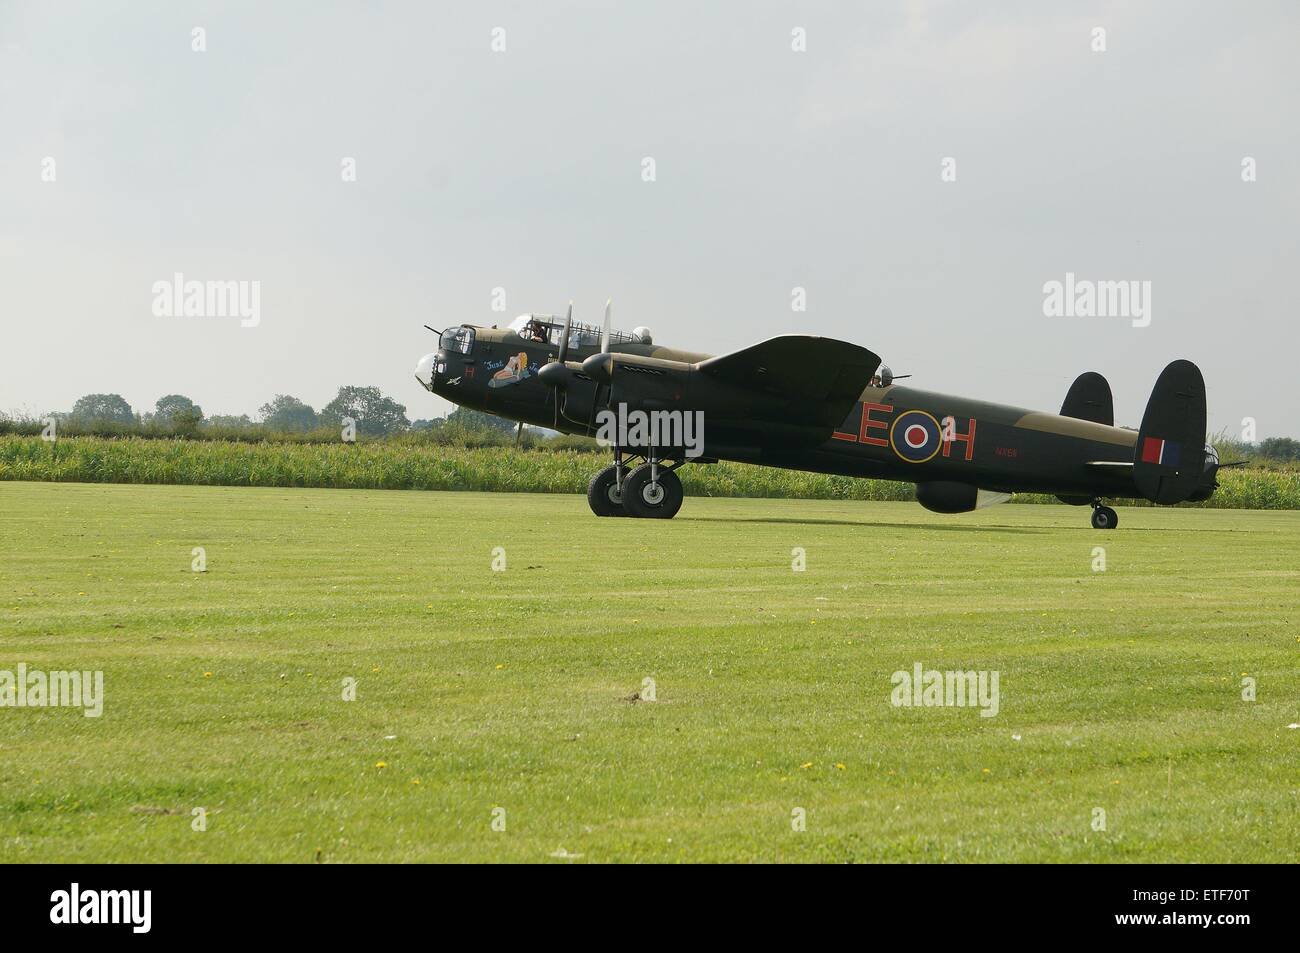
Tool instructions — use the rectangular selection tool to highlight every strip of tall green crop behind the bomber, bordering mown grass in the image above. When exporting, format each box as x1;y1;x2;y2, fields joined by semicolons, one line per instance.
0;436;1300;510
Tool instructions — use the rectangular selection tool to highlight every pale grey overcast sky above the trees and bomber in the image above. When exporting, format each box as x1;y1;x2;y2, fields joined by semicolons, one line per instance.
0;0;1300;438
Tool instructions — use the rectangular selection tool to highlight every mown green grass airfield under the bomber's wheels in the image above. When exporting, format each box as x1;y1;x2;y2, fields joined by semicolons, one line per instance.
0;482;1300;863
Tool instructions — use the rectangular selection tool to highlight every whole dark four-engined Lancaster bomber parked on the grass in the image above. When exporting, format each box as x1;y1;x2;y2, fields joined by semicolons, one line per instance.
416;304;1221;529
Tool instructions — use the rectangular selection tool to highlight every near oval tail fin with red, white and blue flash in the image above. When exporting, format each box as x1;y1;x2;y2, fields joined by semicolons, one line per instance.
1134;360;1205;504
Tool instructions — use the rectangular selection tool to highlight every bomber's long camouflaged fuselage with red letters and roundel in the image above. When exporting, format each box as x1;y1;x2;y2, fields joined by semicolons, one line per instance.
426;321;1213;517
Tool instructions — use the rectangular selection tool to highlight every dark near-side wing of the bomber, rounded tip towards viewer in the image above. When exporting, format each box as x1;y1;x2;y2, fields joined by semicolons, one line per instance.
697;334;880;426
